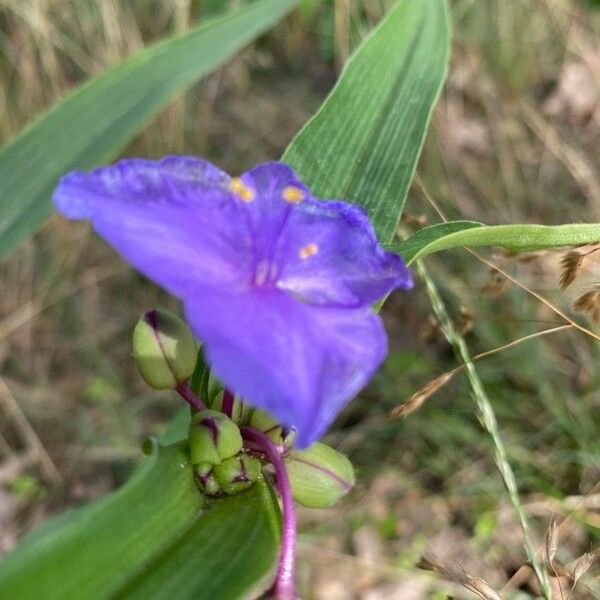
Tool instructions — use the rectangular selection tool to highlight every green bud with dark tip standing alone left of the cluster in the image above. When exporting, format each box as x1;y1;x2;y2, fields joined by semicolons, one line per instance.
133;310;198;390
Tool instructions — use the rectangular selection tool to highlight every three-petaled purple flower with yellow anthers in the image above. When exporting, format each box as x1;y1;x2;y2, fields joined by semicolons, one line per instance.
54;156;412;447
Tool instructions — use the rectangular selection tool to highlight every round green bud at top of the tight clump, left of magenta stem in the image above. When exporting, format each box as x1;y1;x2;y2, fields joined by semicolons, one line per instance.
188;410;242;465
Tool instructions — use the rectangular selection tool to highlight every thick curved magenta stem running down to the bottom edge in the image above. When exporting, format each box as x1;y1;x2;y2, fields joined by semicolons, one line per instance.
240;427;296;600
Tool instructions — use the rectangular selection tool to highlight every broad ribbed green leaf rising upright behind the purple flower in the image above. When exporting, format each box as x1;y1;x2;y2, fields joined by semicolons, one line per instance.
283;0;449;242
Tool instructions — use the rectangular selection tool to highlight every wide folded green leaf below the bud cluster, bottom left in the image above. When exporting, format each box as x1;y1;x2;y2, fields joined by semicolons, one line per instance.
0;445;279;600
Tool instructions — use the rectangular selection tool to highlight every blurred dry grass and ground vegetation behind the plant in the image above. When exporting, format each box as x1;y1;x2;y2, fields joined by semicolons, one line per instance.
0;0;600;600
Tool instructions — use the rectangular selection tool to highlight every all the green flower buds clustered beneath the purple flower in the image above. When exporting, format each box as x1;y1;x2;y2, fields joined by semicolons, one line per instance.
133;310;355;508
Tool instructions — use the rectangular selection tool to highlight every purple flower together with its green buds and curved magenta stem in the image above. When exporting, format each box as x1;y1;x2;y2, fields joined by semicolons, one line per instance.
54;156;412;599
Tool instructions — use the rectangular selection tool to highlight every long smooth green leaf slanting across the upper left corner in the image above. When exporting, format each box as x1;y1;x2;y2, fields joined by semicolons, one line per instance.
0;0;296;256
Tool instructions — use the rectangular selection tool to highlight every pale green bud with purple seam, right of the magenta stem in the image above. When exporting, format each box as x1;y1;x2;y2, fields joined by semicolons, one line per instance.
285;442;356;508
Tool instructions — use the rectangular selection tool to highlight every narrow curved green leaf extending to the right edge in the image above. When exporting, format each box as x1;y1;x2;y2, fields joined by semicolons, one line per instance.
387;221;600;263
